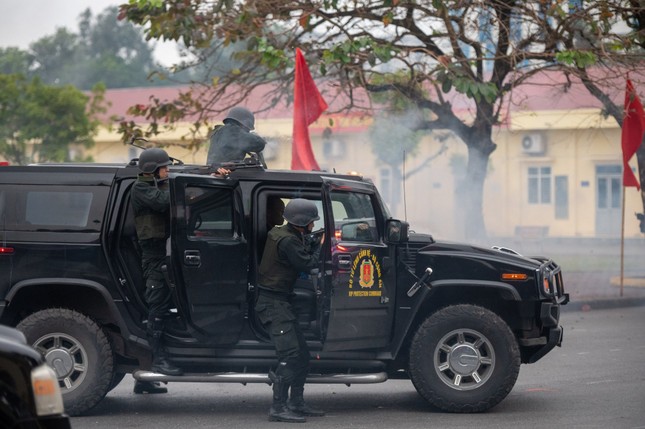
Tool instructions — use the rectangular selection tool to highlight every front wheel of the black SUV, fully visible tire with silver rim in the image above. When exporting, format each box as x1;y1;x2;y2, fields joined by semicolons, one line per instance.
410;304;521;413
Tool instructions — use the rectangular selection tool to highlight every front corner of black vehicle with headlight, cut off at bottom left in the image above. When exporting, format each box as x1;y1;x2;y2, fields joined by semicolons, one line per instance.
0;325;71;429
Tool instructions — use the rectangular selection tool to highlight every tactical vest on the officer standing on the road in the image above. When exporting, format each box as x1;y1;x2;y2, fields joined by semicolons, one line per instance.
258;225;300;293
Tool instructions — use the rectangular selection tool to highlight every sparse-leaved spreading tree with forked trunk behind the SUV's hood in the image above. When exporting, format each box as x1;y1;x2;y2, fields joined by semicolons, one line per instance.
121;0;642;238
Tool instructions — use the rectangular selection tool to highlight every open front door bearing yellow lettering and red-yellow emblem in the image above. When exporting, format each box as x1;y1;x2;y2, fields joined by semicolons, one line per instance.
323;178;396;351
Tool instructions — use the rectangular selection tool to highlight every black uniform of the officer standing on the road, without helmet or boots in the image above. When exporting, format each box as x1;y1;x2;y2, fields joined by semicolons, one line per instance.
255;224;320;408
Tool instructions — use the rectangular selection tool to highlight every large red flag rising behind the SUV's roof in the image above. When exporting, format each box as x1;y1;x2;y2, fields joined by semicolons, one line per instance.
291;48;327;170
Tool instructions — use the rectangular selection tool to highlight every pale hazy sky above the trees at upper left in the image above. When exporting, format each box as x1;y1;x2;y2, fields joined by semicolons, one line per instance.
0;0;179;63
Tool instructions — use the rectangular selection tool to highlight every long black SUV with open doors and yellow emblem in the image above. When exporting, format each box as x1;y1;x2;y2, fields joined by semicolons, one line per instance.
0;160;568;414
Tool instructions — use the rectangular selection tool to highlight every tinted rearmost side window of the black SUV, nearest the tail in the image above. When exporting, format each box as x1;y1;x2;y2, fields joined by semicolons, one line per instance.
6;186;109;232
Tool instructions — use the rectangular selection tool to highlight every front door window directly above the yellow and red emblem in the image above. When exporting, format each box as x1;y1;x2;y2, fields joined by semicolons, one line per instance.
331;191;379;242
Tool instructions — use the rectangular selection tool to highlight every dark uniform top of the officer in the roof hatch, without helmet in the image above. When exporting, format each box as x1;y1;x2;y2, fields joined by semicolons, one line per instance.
207;121;266;166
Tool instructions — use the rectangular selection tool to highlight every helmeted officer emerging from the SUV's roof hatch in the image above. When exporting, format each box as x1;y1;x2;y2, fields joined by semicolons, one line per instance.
207;107;266;168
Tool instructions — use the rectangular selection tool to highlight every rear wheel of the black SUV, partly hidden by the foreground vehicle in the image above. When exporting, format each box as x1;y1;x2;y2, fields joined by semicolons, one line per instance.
18;308;114;416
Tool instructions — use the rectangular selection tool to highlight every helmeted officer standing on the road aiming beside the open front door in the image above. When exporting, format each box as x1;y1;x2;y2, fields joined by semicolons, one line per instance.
255;198;324;422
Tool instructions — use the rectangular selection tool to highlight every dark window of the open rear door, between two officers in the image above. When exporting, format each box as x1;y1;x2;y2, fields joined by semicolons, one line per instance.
186;186;235;239
